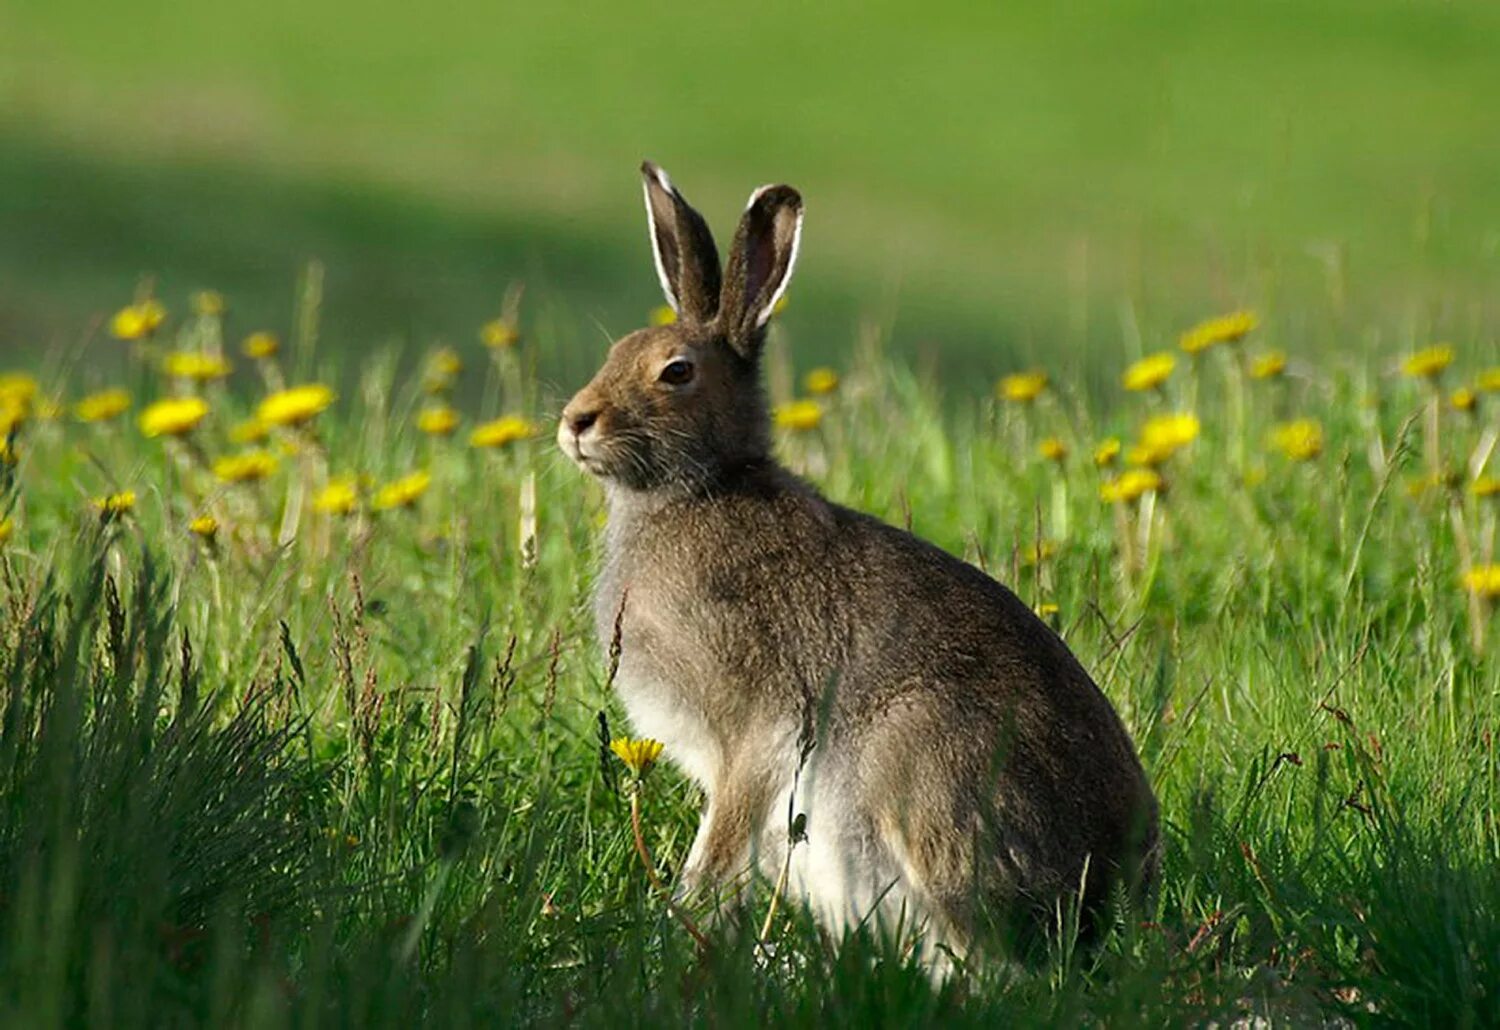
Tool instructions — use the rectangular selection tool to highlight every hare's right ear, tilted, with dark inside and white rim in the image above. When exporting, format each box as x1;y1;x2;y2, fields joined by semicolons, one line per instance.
719;186;803;357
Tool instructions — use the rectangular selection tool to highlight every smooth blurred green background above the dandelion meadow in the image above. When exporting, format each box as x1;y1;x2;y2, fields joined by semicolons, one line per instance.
0;0;1500;381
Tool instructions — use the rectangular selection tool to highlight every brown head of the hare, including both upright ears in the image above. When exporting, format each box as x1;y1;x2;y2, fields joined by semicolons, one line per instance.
558;162;803;490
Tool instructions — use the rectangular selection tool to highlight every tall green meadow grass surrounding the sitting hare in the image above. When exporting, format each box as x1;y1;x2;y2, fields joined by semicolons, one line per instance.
0;293;1500;1026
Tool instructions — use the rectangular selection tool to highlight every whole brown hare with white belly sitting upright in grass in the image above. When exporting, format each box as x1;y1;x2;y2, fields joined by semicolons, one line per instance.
558;162;1158;961
